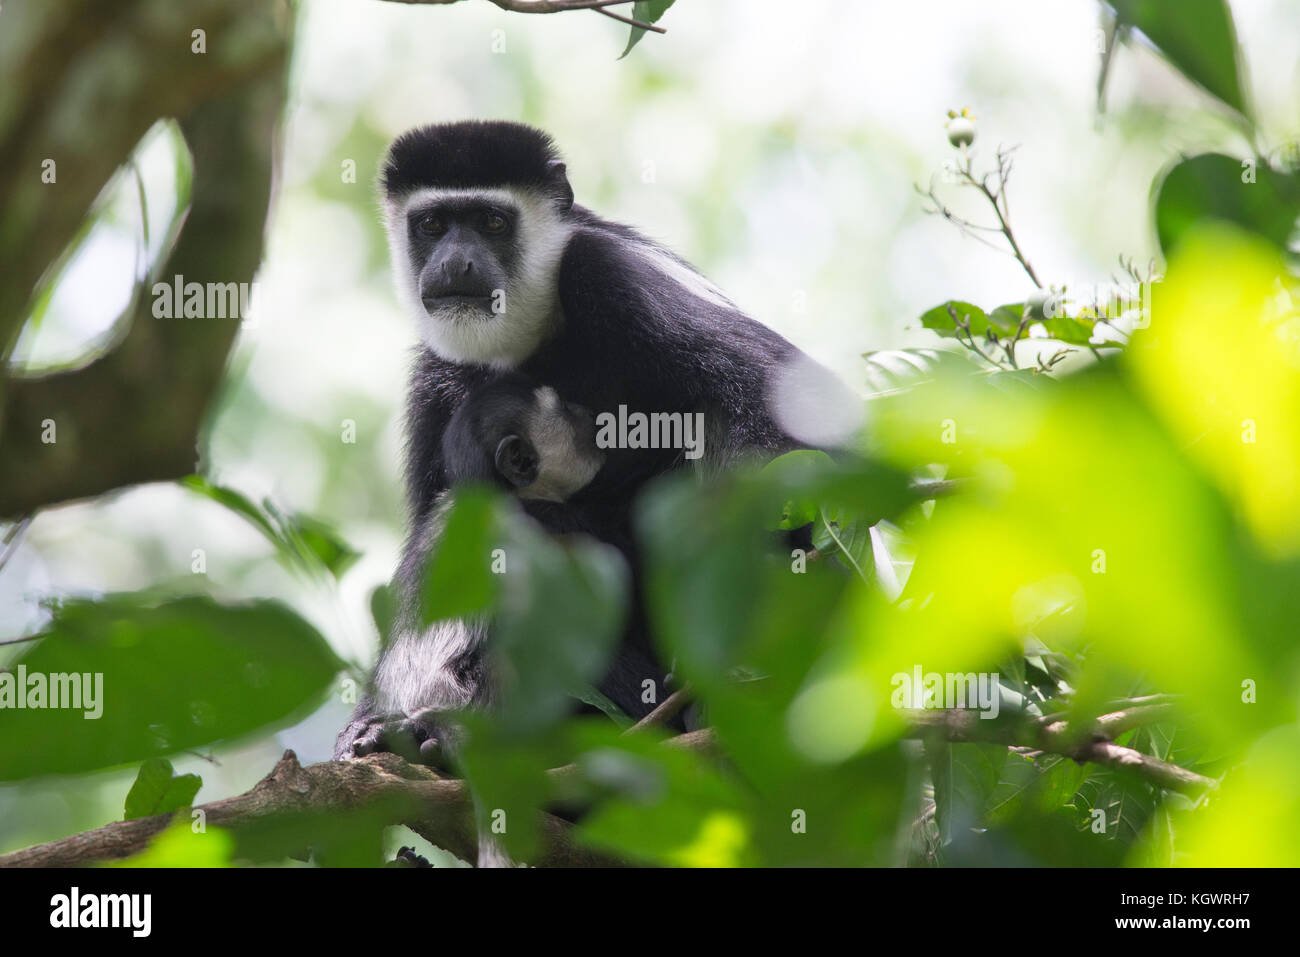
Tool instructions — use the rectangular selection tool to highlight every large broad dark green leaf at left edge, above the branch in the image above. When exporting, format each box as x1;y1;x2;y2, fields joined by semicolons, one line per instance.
0;594;343;781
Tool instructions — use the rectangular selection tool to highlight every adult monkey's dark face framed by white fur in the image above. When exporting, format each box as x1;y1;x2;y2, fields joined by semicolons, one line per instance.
389;189;569;368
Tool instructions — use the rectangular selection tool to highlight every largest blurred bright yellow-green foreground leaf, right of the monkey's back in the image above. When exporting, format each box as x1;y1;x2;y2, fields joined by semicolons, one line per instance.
852;361;1268;744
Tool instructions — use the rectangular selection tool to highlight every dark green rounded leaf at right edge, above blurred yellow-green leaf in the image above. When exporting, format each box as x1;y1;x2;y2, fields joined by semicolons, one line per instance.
1154;153;1300;256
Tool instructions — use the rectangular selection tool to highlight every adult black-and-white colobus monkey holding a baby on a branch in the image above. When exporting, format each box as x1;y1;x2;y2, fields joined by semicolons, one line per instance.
337;122;852;755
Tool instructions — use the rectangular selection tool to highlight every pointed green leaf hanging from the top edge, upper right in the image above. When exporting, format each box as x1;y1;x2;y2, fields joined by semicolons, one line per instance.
1110;0;1249;117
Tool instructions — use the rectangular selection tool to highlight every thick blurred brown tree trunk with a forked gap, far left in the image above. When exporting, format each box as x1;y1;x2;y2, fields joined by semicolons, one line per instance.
0;0;290;518
